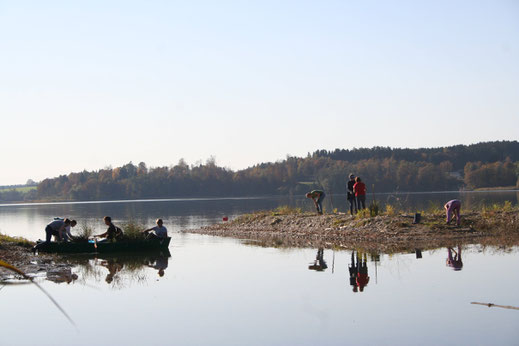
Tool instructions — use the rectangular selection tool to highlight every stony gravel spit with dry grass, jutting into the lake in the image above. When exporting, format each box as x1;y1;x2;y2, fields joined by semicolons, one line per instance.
183;209;519;253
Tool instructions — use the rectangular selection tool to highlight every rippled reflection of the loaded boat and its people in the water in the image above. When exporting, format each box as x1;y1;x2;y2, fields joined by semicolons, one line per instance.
70;250;171;289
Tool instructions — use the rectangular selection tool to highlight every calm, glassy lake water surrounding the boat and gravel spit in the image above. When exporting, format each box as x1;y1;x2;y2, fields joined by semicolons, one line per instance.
0;192;519;345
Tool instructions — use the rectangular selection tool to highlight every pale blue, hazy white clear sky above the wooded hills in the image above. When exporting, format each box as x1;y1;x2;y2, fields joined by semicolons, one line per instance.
0;0;519;185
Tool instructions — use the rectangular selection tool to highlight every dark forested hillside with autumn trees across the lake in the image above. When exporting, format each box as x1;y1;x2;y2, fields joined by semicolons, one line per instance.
0;141;519;200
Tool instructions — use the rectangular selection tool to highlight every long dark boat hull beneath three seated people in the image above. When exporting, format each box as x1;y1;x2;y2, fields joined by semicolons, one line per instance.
38;237;171;253
